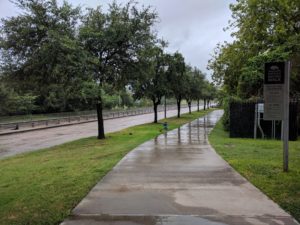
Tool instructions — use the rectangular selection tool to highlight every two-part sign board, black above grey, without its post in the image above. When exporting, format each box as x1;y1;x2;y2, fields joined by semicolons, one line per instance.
264;62;285;120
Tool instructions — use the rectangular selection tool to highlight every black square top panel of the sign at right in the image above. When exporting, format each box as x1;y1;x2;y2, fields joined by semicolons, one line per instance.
265;62;284;84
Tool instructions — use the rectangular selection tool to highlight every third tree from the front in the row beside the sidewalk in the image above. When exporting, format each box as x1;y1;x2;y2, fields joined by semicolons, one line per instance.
167;52;186;118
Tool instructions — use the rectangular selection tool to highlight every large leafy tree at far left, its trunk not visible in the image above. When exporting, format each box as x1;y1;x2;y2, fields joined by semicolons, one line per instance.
0;0;86;111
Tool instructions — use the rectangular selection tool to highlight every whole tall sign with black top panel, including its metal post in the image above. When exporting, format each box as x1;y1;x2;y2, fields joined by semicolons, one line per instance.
264;62;290;172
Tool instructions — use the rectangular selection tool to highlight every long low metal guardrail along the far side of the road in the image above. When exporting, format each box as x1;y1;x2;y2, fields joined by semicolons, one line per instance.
0;105;192;133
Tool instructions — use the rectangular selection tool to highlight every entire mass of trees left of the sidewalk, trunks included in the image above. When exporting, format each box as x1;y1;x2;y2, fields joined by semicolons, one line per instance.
0;0;215;138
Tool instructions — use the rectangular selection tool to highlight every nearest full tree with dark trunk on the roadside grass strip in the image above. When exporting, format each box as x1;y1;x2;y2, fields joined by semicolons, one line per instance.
80;2;157;139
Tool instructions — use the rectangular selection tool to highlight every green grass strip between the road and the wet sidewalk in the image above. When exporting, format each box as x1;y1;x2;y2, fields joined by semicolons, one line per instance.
0;111;213;225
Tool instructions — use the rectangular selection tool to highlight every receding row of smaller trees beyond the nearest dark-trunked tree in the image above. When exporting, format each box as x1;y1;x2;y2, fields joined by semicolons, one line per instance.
130;41;216;123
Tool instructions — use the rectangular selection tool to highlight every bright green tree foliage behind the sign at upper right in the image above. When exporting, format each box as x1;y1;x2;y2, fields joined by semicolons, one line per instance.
208;0;300;99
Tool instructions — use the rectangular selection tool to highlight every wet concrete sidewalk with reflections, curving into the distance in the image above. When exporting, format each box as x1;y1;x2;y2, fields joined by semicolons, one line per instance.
62;111;298;225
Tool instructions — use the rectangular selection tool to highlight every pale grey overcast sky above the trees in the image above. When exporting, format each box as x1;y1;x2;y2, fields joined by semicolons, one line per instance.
0;0;235;79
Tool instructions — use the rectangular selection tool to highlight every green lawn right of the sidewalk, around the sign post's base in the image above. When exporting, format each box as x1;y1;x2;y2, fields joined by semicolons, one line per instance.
209;122;300;221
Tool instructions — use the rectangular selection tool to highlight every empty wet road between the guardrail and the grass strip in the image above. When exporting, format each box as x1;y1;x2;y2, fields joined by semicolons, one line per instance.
0;107;196;158
